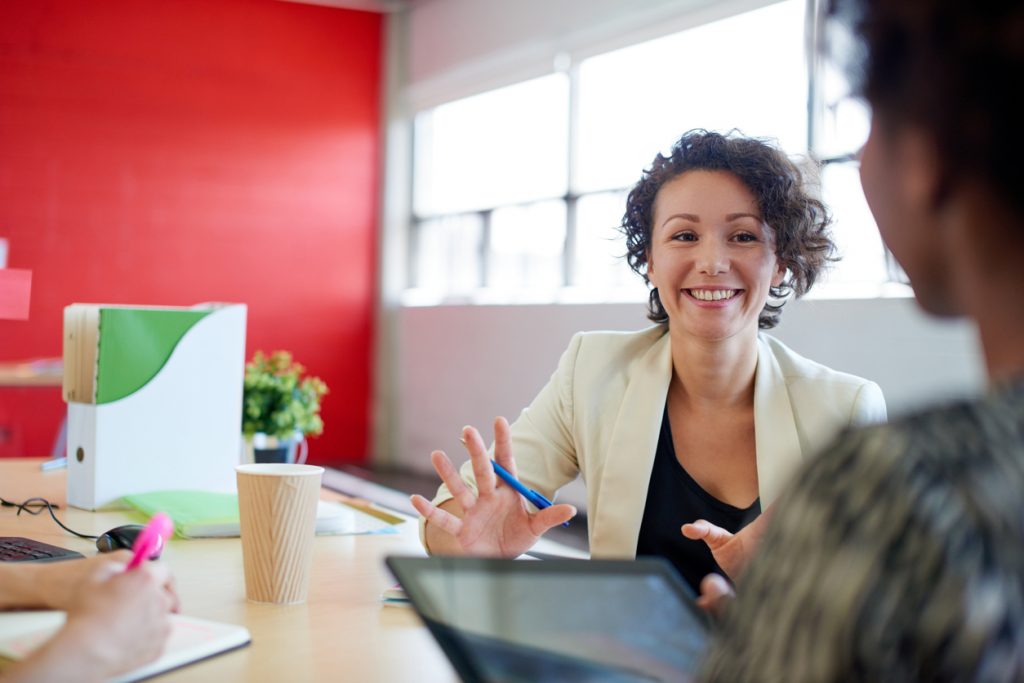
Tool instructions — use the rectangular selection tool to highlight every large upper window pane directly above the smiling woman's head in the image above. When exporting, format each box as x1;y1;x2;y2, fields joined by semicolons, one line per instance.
574;0;807;193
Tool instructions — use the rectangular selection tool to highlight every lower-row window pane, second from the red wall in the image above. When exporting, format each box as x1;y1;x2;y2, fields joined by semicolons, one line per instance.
487;201;565;292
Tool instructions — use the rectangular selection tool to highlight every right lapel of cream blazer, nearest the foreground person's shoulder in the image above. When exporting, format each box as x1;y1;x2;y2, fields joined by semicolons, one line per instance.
754;336;803;510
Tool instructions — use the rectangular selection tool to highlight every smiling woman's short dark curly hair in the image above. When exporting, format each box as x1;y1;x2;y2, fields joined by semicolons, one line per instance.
620;129;836;330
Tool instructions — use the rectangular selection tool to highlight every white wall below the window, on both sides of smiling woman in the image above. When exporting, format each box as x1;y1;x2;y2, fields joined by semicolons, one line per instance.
392;298;984;491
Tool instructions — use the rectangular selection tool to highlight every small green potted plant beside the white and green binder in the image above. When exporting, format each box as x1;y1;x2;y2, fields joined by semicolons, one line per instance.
242;350;328;463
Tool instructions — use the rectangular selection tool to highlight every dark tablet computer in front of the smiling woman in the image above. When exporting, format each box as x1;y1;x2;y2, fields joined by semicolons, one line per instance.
386;557;709;683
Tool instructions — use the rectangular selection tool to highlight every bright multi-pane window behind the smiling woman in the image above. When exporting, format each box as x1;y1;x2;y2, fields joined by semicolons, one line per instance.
407;0;898;304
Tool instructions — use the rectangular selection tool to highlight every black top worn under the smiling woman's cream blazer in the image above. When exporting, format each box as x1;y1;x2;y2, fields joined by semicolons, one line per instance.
637;407;761;593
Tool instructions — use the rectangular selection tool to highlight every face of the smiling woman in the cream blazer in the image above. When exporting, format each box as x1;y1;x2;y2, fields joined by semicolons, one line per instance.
647;171;785;341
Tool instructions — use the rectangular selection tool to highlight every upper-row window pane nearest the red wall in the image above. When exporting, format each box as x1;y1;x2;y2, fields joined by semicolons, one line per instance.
414;74;568;216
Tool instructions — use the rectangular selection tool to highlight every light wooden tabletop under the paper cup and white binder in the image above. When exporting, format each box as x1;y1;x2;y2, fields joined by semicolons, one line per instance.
0;459;459;683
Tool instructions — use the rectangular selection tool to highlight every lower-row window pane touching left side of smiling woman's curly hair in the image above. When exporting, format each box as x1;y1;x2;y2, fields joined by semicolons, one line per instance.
572;193;643;292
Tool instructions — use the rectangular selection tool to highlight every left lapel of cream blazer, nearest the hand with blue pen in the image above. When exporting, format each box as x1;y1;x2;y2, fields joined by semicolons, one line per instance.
590;333;672;557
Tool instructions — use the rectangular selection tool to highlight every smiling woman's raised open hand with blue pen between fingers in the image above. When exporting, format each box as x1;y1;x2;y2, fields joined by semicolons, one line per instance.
412;418;575;557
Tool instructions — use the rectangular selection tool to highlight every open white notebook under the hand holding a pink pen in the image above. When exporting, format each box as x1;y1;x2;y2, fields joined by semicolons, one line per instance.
0;611;251;683
